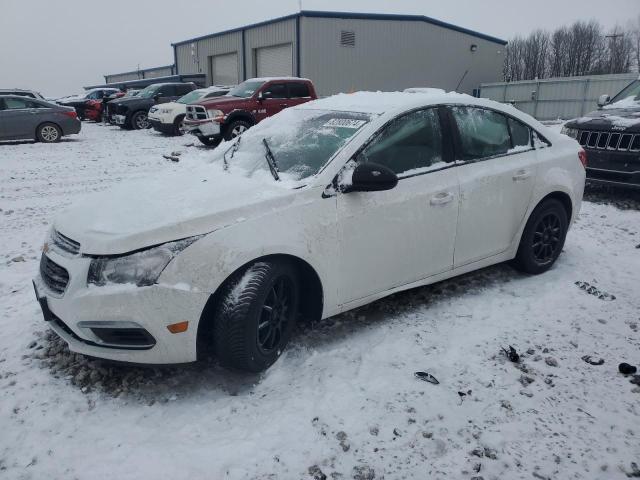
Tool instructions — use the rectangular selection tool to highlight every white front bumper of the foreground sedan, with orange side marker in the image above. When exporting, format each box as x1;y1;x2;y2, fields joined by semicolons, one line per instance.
33;250;209;364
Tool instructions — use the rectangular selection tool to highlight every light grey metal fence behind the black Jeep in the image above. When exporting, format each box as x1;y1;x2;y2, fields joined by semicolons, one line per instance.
480;73;638;120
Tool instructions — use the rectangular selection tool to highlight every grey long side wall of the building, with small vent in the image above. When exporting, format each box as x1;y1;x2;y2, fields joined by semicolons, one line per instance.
300;17;504;95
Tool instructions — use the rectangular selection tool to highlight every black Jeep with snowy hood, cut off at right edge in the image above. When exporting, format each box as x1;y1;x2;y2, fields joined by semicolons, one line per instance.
563;79;640;188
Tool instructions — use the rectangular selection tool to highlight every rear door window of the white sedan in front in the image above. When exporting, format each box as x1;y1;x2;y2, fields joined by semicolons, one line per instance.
451;106;511;160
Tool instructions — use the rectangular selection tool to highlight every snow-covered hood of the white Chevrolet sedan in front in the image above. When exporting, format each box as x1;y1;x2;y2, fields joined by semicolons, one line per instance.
53;164;295;255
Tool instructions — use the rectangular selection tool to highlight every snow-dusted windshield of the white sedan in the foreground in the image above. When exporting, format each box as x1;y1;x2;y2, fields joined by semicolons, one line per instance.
213;109;371;181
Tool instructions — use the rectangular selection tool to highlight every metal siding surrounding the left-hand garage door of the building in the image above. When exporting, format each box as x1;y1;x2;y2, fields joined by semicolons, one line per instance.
175;32;242;85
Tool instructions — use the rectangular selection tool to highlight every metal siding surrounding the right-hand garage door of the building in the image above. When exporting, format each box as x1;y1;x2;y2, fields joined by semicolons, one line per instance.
244;19;297;78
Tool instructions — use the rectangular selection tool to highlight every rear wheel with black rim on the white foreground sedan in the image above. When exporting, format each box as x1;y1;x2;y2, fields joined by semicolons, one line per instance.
513;198;569;275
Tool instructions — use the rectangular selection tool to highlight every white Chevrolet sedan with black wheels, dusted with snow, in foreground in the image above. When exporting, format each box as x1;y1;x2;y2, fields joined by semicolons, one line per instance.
34;92;586;372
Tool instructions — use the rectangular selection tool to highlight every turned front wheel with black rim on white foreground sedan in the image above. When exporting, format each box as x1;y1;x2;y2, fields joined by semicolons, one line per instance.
213;260;300;373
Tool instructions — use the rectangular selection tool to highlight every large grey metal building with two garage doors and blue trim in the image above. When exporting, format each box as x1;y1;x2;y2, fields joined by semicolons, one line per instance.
173;11;507;95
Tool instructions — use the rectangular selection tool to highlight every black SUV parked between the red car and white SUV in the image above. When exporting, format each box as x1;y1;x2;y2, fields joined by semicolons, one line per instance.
110;83;197;130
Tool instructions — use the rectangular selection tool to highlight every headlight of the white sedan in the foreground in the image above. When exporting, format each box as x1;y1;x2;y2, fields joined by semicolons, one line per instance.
87;236;200;287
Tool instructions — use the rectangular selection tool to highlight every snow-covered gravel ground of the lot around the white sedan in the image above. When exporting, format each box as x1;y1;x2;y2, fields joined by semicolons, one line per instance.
0;123;640;480
